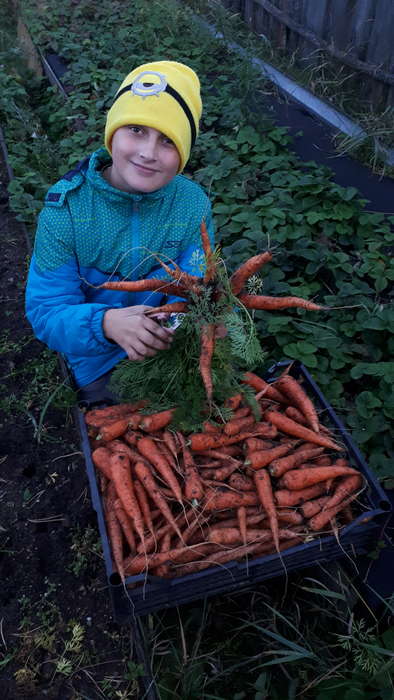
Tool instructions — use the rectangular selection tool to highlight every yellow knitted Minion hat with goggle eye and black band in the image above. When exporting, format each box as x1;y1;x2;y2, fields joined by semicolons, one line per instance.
104;61;202;172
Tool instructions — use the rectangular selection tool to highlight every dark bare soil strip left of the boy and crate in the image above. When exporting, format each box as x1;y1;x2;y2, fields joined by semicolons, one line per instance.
0;156;145;700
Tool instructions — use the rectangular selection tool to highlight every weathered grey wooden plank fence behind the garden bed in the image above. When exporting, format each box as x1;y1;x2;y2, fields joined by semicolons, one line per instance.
221;0;394;109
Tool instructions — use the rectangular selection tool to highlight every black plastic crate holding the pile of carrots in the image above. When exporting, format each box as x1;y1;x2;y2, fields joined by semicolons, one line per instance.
77;362;391;622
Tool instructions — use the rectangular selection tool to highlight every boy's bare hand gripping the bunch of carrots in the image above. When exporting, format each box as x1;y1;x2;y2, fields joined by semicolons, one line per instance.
103;306;173;361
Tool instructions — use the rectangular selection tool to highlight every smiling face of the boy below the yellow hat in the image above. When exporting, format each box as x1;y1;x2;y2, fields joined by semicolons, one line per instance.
104;124;180;192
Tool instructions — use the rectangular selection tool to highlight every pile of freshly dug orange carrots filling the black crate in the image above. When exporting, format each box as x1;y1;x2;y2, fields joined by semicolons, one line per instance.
85;370;364;581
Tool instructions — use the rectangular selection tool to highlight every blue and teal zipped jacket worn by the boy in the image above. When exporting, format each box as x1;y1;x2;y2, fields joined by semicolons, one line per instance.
26;149;213;386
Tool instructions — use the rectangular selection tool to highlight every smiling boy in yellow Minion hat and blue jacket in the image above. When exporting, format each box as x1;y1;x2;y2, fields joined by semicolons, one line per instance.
26;61;213;408
